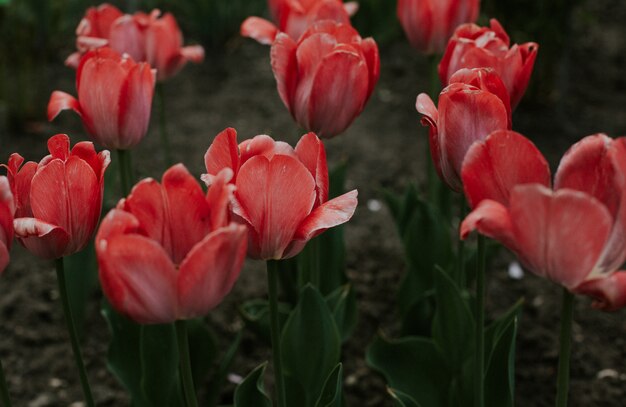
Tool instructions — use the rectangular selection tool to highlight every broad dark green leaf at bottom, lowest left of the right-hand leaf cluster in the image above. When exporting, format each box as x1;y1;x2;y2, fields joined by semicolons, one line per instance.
366;335;451;407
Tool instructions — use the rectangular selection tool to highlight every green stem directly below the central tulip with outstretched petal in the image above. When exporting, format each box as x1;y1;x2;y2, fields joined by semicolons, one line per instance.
267;260;286;407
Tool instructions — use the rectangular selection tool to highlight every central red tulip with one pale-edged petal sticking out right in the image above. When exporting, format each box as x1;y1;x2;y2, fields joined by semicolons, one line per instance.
203;129;357;260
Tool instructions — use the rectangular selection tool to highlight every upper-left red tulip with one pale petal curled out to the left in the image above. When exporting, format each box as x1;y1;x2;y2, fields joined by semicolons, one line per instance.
48;48;156;150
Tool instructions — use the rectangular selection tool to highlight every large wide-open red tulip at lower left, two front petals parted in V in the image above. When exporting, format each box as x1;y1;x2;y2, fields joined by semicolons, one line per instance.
96;164;246;324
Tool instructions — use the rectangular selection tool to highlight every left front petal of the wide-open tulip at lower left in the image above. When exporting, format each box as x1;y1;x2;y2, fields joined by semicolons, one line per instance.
98;235;178;324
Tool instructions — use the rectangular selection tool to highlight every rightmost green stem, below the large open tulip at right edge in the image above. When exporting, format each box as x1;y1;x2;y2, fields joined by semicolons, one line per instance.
556;288;574;407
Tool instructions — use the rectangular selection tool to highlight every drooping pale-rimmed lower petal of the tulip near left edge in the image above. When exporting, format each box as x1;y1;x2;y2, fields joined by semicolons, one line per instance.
13;218;70;259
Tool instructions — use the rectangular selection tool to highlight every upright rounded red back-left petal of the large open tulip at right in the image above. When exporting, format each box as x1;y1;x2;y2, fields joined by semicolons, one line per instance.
461;130;550;208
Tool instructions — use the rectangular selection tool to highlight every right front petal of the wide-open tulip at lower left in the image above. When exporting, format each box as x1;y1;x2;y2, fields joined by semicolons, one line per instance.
178;224;246;318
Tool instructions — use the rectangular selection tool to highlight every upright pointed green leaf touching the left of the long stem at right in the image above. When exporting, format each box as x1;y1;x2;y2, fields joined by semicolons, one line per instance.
432;269;475;372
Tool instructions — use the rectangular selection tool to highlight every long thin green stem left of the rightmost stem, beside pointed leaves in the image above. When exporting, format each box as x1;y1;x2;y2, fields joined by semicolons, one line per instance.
474;235;486;407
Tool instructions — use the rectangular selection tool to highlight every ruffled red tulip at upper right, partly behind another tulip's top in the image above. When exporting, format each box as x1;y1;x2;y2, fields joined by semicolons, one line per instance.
439;19;539;108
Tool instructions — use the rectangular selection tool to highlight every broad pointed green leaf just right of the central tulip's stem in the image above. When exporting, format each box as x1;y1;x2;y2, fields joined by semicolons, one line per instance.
281;284;341;407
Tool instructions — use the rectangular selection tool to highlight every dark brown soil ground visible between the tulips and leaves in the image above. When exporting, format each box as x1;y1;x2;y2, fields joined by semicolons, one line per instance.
0;0;626;407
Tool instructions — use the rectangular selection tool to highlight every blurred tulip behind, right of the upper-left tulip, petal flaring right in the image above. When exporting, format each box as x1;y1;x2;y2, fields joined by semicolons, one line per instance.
140;10;204;82
